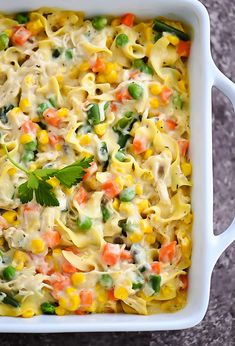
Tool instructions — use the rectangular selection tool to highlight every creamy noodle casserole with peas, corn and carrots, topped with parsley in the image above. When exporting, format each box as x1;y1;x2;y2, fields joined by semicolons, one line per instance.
0;8;192;317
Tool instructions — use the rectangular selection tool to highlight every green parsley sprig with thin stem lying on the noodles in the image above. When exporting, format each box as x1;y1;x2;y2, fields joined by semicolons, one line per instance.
2;144;93;207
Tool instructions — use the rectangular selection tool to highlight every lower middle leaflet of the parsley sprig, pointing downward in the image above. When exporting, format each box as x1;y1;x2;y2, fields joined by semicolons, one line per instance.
35;180;59;207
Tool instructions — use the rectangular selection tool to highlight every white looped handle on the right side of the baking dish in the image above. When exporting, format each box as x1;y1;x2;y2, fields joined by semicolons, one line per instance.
212;62;235;264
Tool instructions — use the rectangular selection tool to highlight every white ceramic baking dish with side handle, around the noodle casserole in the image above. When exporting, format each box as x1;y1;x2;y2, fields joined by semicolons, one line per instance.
0;0;235;333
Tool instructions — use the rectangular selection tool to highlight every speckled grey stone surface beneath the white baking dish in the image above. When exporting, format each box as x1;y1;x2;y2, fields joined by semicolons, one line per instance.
0;0;235;346
